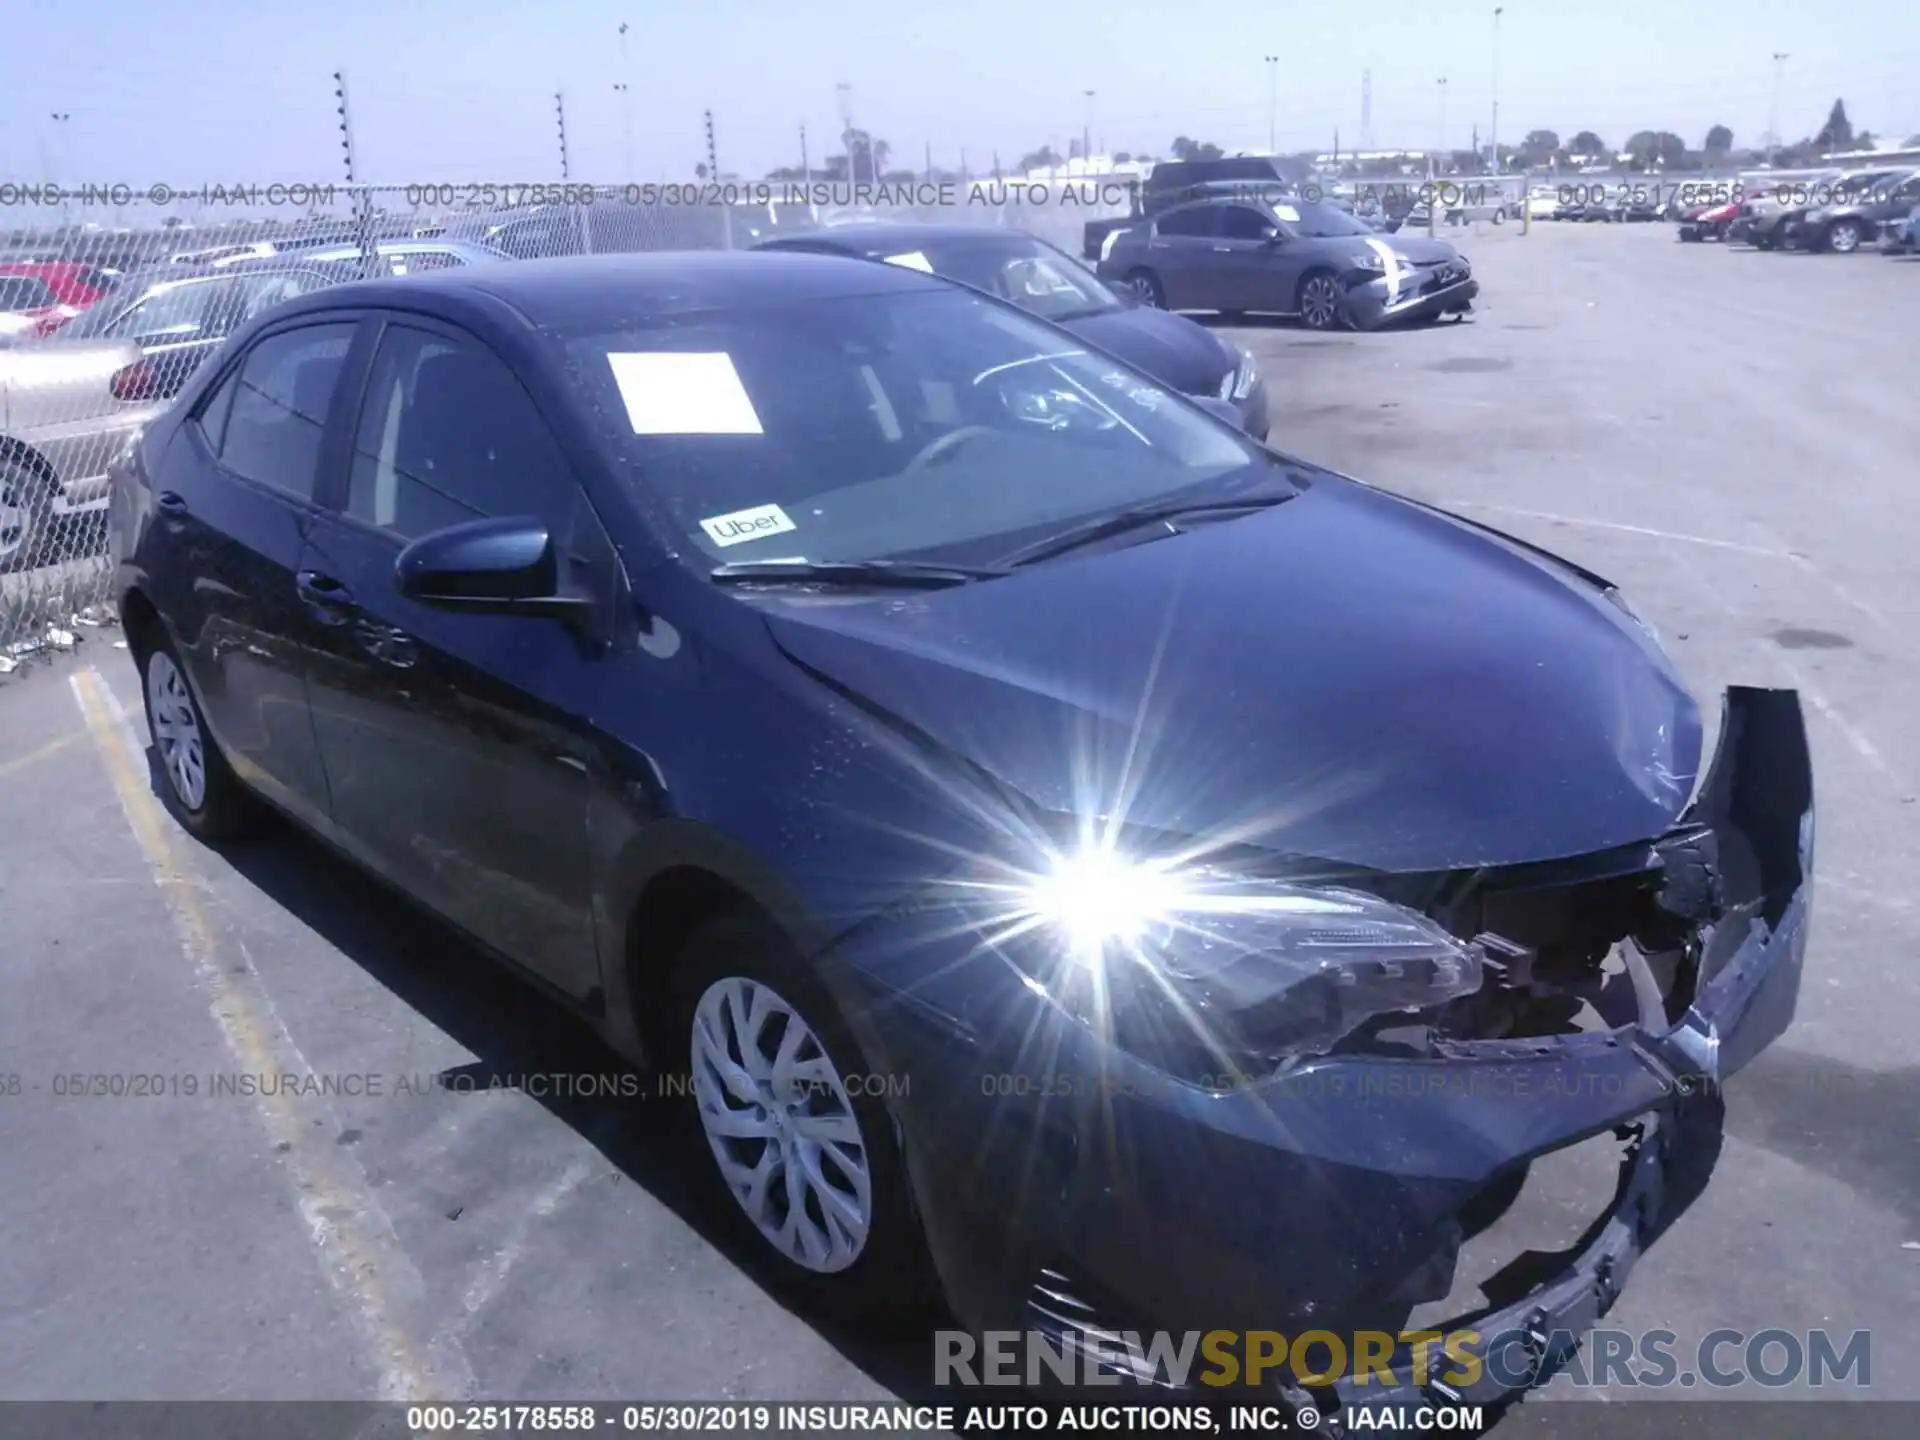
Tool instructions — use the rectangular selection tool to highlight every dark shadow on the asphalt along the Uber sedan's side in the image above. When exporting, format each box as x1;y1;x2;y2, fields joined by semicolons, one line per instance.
146;745;954;1404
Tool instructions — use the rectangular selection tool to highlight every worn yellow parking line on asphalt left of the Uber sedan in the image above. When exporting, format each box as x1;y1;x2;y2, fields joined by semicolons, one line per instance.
69;666;472;1400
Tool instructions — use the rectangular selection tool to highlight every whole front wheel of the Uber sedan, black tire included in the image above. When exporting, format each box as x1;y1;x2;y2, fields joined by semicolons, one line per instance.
662;914;937;1323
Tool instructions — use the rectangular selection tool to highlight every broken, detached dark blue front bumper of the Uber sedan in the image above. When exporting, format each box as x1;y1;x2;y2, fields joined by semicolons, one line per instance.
867;689;1812;1405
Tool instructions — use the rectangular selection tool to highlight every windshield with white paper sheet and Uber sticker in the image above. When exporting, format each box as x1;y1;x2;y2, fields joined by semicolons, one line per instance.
568;290;1286;566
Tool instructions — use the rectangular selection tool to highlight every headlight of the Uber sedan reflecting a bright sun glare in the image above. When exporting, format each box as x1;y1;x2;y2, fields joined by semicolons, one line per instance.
1012;847;1482;1089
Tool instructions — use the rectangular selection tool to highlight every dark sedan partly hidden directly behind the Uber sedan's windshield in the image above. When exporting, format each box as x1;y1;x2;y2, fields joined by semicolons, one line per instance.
758;225;1269;440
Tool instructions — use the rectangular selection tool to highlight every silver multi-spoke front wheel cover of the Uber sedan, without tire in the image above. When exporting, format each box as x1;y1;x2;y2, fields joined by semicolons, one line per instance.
691;975;874;1275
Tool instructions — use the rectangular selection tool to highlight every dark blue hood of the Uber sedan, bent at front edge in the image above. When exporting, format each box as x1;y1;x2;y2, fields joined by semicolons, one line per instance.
768;478;1701;872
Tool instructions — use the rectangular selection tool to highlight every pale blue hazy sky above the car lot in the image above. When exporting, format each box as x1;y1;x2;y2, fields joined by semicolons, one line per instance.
0;0;1920;194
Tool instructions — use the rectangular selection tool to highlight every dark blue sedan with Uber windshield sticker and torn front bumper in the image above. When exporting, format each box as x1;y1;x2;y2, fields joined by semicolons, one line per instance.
111;253;1812;1402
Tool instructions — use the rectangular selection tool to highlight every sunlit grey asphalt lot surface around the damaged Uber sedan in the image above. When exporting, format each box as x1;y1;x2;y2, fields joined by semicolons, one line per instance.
0;225;1920;1434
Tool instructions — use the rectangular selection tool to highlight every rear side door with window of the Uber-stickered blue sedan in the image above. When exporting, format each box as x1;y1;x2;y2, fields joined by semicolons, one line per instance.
146;319;359;829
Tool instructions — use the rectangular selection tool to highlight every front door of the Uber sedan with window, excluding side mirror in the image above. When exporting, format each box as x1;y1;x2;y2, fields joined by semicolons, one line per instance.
300;317;618;996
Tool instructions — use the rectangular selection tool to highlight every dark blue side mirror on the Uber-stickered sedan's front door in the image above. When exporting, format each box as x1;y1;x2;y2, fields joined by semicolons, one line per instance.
394;516;593;620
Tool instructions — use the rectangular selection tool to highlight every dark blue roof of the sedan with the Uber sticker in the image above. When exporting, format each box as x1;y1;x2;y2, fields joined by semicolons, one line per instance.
276;250;945;330
